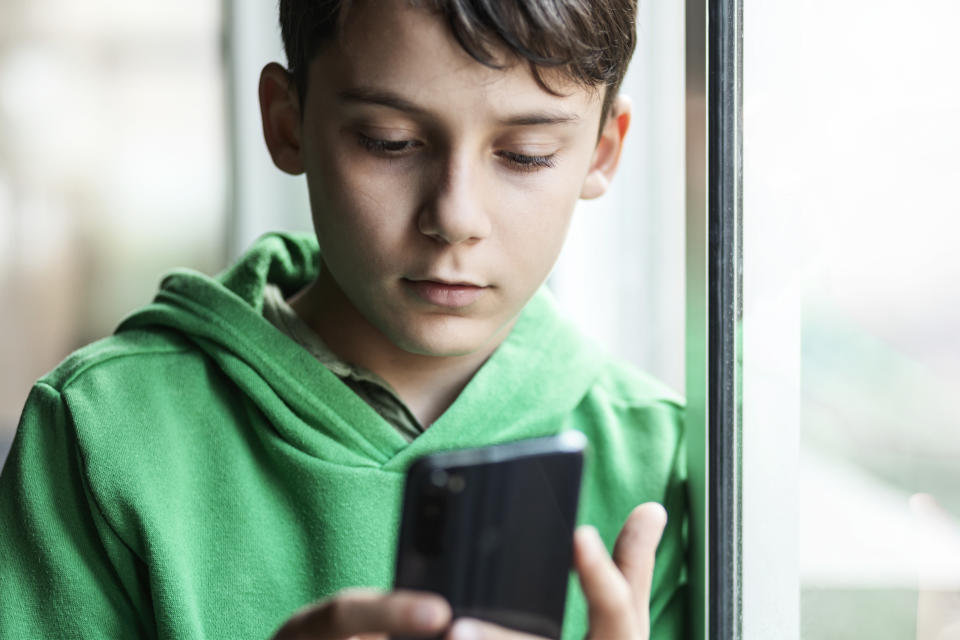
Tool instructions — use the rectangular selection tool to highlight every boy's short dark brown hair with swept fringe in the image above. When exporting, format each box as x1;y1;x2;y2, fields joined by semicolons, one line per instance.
280;0;637;115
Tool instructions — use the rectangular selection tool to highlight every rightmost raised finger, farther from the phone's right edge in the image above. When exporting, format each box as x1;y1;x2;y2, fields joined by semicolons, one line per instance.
613;502;667;614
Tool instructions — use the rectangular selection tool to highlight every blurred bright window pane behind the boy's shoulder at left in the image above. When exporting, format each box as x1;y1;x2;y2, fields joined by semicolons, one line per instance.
0;0;226;462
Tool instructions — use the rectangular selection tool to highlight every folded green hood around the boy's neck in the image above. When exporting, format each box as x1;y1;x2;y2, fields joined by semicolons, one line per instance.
117;233;603;470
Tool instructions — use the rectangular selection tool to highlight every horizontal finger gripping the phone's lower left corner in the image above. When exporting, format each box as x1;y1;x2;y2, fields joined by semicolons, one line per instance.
274;589;451;640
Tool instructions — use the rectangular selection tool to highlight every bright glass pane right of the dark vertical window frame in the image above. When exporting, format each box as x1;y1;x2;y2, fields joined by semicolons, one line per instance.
743;0;960;640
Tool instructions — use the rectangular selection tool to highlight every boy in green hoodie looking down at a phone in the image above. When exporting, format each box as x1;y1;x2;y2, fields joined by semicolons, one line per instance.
0;0;683;639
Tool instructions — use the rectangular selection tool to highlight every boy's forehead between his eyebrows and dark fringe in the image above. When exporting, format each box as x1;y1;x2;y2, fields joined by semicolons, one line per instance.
310;0;602;121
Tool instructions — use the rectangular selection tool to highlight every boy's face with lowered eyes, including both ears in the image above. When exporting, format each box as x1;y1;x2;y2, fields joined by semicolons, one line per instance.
261;0;629;356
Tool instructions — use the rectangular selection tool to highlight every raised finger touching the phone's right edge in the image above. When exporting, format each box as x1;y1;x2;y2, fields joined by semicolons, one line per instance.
573;526;643;638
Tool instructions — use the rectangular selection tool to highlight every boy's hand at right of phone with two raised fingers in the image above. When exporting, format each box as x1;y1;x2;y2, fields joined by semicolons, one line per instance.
446;502;667;640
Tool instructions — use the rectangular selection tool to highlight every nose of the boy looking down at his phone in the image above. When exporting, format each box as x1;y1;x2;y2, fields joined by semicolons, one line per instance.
417;154;491;245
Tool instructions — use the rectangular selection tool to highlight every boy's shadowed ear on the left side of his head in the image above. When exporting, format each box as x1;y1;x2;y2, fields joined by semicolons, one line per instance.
260;62;303;175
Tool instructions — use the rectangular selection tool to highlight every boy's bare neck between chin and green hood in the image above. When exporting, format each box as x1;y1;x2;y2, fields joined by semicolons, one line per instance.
290;269;511;427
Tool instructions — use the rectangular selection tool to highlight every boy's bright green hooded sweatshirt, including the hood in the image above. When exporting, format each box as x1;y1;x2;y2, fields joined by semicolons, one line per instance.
0;235;685;639
